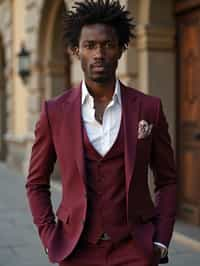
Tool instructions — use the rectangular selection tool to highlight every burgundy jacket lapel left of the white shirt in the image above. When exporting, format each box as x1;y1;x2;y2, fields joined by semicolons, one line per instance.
63;86;85;181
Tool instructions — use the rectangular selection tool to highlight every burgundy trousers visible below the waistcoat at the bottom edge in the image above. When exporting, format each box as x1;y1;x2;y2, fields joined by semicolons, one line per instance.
59;237;158;266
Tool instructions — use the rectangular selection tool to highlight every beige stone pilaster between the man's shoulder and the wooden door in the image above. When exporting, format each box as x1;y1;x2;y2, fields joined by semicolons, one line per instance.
137;25;176;140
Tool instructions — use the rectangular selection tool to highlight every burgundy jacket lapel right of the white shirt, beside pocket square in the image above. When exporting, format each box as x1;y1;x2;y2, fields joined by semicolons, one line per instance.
121;84;140;194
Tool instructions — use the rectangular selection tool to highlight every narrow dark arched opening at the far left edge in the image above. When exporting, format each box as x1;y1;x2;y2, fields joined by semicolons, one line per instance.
0;35;7;161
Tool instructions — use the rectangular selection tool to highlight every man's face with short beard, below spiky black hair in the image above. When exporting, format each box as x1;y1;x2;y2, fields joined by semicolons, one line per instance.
77;24;122;83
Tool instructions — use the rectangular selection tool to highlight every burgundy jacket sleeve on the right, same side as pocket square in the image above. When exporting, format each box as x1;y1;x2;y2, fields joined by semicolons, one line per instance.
150;101;177;246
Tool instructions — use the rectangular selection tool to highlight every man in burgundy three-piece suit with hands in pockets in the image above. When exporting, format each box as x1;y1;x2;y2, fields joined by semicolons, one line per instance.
26;0;176;266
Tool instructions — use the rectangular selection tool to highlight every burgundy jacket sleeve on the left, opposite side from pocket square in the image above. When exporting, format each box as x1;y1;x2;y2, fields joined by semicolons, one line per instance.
26;102;56;248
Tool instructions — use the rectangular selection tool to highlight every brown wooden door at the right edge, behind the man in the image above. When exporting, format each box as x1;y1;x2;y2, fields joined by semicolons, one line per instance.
176;1;200;224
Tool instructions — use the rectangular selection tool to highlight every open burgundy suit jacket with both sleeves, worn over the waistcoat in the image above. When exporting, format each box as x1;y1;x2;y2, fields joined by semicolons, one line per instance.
26;84;176;262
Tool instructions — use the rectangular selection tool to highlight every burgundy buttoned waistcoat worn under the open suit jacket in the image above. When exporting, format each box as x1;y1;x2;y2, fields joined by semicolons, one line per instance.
83;117;130;243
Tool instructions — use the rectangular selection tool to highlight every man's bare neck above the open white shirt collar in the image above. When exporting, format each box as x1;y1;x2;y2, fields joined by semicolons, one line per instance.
85;79;116;100
